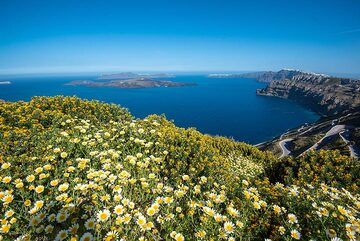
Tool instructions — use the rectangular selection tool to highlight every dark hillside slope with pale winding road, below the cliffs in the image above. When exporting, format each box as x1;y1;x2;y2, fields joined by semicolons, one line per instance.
257;111;360;158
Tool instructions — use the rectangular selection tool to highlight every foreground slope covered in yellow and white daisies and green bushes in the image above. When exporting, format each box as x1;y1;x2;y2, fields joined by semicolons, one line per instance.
0;97;360;241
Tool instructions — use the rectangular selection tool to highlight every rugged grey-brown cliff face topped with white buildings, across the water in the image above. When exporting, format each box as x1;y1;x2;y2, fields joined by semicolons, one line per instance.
257;71;360;115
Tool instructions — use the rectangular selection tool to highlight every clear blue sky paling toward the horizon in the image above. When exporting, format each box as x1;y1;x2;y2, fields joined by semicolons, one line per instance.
0;0;360;74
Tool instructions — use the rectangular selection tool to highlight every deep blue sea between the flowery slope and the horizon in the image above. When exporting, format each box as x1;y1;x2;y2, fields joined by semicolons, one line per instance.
0;75;319;144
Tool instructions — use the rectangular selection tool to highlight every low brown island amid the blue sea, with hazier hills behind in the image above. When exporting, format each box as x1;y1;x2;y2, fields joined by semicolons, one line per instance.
66;72;196;89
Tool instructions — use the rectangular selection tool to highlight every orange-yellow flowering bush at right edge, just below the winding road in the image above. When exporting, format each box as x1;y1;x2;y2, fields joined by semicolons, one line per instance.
266;150;360;192
